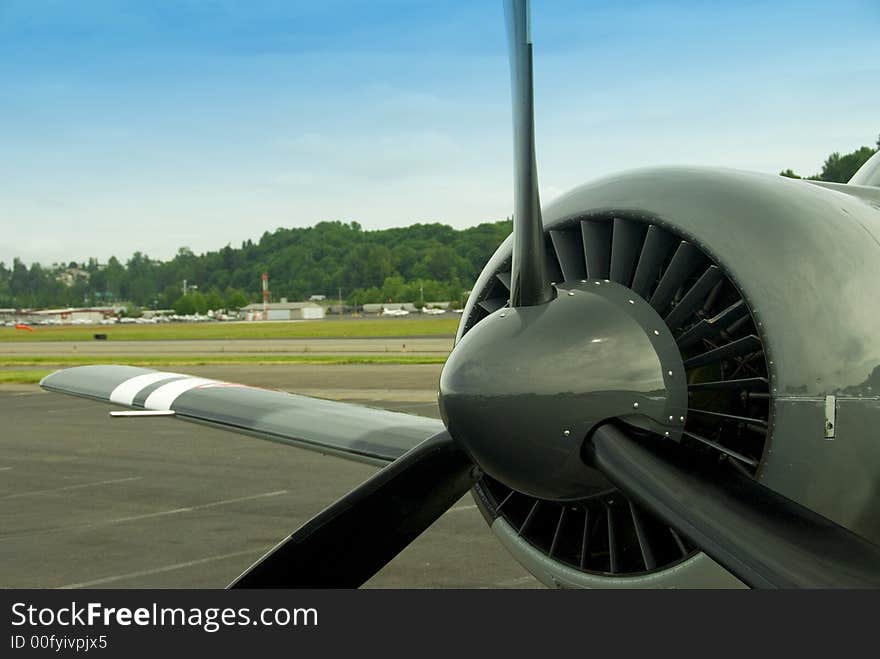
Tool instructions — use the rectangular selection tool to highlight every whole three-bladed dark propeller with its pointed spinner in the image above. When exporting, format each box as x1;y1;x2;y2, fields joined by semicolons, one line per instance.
231;0;880;588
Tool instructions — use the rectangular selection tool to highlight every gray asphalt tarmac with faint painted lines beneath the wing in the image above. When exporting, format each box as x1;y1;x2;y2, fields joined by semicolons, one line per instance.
0;364;540;588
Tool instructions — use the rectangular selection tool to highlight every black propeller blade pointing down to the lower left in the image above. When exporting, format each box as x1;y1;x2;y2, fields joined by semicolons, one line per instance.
229;431;473;588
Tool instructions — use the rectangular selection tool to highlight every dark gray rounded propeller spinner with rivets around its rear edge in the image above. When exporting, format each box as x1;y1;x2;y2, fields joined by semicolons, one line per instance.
440;280;687;501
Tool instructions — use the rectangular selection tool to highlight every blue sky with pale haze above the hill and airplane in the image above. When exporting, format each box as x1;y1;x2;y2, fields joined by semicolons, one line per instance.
0;0;880;264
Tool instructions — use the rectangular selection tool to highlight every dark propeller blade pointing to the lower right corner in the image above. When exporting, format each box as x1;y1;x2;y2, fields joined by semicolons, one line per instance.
589;424;880;588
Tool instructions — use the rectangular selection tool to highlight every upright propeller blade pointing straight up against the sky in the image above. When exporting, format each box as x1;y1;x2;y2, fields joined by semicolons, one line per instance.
504;0;554;307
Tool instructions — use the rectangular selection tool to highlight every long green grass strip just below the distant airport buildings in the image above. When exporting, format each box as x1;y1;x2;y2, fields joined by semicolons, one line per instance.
0;315;459;342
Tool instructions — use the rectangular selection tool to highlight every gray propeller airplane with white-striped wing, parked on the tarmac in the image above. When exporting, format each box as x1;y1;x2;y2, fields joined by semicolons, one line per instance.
41;0;880;588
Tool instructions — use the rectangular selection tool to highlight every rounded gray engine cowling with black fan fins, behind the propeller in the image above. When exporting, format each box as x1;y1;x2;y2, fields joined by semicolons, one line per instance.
450;168;880;587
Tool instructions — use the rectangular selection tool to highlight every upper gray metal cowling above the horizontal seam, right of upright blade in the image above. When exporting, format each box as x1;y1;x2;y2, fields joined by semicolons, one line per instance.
532;168;880;397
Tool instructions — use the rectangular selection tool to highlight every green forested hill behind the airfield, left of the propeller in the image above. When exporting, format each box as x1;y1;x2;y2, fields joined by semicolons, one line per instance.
0;221;511;312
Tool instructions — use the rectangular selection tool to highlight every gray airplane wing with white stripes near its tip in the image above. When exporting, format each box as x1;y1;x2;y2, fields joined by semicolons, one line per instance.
40;366;445;466
